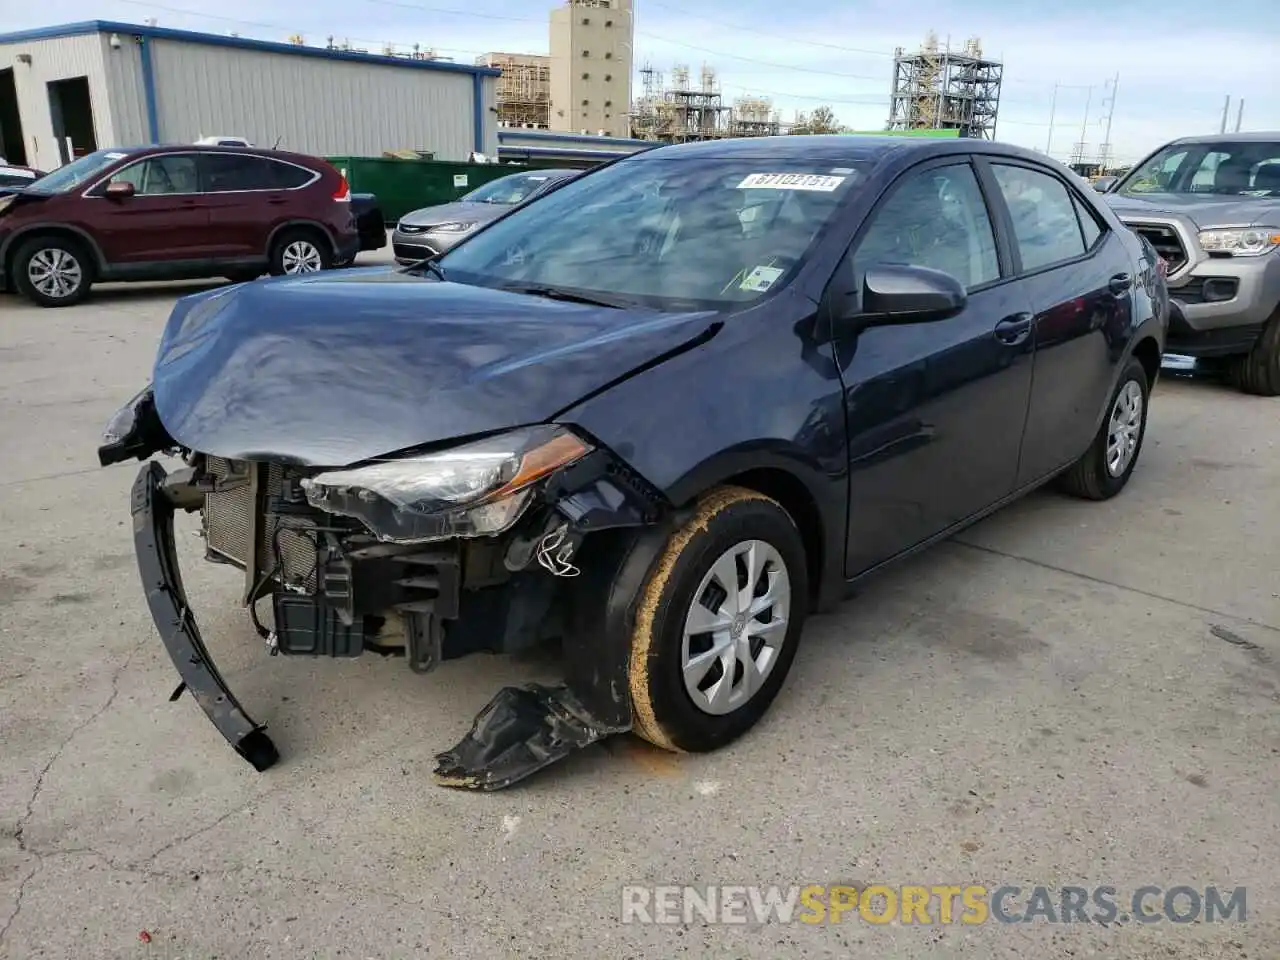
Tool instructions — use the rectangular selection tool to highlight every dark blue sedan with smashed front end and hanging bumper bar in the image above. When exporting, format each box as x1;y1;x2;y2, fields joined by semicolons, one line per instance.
99;136;1167;788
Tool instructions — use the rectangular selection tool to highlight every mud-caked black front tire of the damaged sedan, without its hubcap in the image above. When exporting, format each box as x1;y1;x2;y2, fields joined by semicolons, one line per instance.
628;486;809;753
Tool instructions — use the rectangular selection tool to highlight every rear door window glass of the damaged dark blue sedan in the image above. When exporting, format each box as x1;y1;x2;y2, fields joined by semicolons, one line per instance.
991;164;1085;271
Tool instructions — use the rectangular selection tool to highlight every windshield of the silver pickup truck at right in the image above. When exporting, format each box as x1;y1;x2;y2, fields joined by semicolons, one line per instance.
1117;140;1280;197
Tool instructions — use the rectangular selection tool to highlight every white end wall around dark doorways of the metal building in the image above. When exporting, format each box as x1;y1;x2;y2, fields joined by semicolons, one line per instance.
0;35;116;170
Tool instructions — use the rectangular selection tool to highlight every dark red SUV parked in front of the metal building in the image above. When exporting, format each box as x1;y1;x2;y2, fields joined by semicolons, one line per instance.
0;146;360;307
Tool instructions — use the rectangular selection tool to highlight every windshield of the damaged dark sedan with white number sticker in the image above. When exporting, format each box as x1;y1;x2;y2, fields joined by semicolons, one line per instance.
439;157;867;308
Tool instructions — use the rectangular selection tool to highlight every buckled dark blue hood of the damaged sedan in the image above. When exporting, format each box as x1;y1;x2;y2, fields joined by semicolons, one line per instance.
152;268;716;466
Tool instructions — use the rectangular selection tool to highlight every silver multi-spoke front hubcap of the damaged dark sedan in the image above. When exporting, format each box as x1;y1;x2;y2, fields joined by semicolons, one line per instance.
681;540;791;716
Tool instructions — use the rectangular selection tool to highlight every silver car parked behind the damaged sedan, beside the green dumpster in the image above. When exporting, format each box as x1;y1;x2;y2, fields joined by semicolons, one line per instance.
392;170;581;264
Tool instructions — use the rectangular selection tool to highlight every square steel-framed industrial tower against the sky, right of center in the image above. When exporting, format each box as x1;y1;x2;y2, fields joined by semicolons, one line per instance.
887;32;1005;140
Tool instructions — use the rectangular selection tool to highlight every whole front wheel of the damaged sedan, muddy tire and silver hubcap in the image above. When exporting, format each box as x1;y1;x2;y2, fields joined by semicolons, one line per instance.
628;486;809;753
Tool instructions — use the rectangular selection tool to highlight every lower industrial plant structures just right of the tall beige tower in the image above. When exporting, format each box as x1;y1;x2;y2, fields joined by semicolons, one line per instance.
631;64;781;143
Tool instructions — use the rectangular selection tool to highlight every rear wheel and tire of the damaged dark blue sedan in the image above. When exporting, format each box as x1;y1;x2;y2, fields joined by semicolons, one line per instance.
1059;357;1151;500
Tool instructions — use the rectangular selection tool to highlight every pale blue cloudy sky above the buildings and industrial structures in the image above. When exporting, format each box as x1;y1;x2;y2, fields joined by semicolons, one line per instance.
12;0;1280;160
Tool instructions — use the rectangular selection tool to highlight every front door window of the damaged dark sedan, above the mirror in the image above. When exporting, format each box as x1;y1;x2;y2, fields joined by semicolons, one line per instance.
852;164;1000;289
